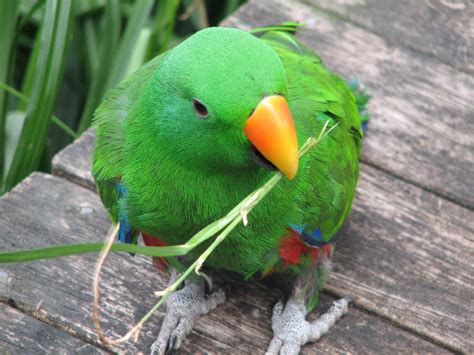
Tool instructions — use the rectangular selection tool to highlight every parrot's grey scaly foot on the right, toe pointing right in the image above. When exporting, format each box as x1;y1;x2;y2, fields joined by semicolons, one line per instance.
267;298;349;355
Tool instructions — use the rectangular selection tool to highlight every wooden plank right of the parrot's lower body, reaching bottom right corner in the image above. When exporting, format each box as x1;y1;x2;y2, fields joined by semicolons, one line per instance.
334;165;474;352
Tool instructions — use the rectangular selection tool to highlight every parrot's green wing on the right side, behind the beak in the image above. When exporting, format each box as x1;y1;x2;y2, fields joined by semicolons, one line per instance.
259;29;363;247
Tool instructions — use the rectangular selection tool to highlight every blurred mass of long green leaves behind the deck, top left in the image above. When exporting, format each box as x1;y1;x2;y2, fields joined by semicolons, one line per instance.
0;0;245;194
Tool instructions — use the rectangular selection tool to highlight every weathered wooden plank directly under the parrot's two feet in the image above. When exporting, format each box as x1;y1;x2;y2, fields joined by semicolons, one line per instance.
0;174;444;354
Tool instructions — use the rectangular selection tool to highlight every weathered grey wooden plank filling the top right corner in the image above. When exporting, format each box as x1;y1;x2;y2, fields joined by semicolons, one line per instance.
304;0;474;73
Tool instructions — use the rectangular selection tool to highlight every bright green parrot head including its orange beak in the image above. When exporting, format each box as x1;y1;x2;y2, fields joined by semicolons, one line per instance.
144;28;298;179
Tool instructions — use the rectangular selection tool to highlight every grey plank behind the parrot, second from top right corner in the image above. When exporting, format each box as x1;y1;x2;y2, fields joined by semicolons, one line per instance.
223;0;474;209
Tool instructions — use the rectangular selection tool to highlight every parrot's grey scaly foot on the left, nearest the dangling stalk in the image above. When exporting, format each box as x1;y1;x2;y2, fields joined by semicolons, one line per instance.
151;280;225;355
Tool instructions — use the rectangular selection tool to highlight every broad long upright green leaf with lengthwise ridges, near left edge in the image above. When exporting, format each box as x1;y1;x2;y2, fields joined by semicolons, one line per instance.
3;0;72;191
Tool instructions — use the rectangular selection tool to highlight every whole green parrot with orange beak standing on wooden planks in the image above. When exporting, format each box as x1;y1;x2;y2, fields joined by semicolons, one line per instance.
93;24;366;354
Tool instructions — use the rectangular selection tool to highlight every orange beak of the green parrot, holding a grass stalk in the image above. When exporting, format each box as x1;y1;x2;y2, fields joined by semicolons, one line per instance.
244;95;299;180
